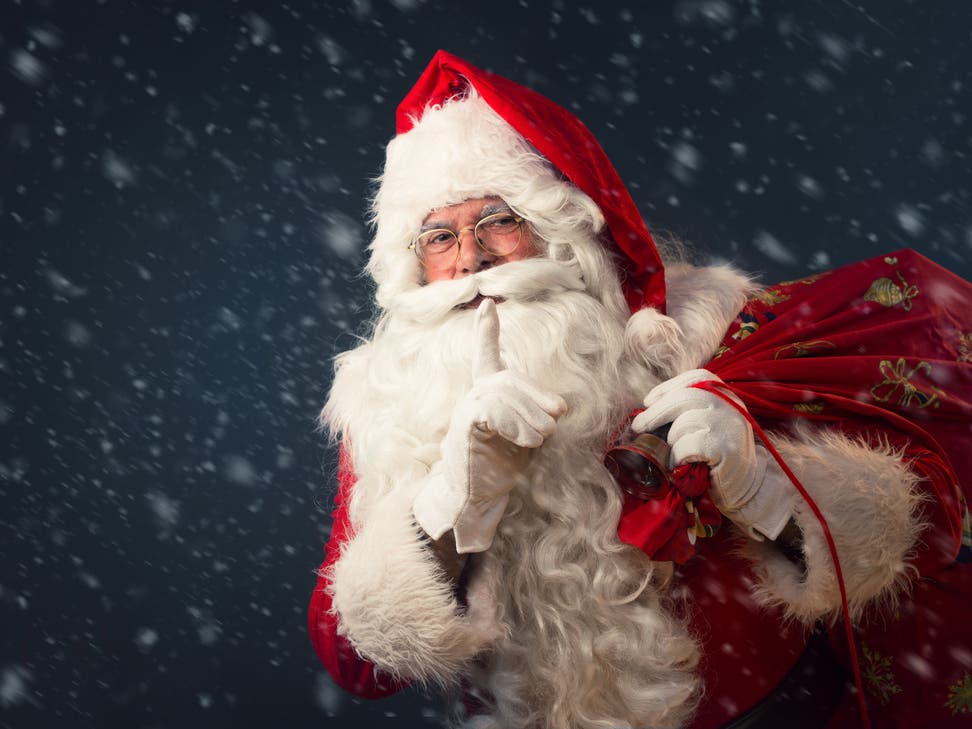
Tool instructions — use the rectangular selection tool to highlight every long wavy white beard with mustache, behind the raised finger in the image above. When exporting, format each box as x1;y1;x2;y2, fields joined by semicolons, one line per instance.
322;258;697;728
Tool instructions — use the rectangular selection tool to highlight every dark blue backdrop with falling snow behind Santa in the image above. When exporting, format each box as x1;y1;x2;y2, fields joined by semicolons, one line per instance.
0;0;972;727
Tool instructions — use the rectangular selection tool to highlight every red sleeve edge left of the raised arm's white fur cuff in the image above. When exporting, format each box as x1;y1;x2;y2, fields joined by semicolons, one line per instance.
307;446;408;699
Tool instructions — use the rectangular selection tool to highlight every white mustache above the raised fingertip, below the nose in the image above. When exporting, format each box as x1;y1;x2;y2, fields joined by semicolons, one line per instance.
390;258;585;324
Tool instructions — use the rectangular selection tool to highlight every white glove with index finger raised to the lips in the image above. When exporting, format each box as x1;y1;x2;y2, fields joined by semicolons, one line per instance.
412;299;567;554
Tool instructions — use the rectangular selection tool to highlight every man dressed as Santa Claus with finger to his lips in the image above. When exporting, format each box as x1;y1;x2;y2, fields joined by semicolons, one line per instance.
310;52;972;729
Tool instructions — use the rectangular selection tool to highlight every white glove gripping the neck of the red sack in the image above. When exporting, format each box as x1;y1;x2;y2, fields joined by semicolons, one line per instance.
631;369;797;540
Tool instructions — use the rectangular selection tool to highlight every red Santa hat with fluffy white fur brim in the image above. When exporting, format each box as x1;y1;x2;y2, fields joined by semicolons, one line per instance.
369;51;665;312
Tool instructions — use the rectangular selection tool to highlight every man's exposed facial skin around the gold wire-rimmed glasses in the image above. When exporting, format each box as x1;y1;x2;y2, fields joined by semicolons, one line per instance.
422;197;540;283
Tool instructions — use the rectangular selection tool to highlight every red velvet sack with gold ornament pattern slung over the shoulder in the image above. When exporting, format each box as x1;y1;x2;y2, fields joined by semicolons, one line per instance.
619;250;972;572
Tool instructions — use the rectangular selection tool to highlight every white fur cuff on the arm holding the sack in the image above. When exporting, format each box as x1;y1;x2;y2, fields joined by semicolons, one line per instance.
743;427;924;624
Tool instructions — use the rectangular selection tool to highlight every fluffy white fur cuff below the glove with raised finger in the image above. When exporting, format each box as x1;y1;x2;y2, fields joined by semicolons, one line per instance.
328;480;498;686
